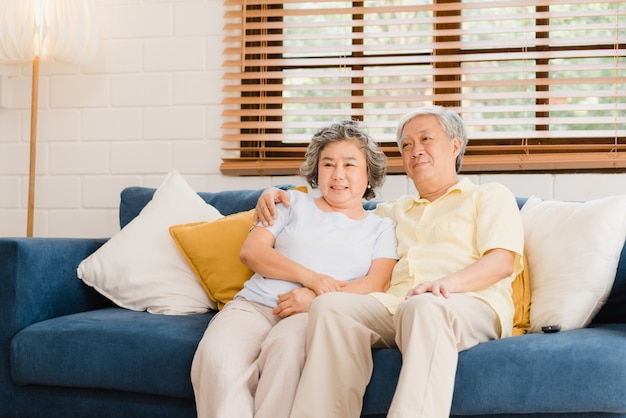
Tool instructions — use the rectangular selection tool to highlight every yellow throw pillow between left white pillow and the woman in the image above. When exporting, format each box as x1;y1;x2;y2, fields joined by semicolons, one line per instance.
170;209;254;309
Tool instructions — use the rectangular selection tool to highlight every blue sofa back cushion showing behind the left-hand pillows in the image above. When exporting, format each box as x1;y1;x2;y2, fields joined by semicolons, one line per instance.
120;184;295;228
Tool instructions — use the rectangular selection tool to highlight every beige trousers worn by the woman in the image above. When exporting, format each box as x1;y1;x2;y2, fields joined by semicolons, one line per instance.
191;299;308;418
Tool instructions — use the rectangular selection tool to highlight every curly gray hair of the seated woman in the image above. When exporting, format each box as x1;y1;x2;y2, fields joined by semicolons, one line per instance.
300;120;387;200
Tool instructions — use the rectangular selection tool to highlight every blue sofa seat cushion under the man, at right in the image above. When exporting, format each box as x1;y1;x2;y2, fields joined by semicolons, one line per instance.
363;324;626;417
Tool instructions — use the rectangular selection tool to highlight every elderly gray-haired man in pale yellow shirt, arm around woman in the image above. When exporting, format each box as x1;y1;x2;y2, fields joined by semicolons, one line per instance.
258;106;523;418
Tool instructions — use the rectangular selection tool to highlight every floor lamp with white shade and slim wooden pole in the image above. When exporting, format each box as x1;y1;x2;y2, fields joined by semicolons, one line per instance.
0;0;98;237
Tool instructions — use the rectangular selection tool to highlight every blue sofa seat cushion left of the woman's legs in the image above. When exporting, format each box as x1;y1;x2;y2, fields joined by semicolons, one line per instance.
11;307;215;399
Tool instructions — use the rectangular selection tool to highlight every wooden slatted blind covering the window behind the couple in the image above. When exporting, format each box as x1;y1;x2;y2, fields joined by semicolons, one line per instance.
221;0;626;175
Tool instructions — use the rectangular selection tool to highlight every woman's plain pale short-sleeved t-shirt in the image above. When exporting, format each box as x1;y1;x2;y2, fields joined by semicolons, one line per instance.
235;191;398;307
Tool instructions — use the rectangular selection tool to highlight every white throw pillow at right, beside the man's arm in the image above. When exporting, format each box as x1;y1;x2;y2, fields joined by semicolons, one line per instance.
521;195;626;332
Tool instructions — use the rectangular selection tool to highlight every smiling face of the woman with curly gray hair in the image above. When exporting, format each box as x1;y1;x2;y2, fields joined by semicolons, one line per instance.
317;140;368;207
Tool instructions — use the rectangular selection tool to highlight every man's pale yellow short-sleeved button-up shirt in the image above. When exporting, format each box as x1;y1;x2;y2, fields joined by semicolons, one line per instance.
372;178;524;337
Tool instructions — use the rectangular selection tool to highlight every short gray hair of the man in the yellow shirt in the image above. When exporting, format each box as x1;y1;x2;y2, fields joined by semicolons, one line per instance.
396;106;468;173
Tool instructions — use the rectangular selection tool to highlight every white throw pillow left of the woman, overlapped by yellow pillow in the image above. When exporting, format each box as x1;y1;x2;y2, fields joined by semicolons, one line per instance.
77;170;222;315
